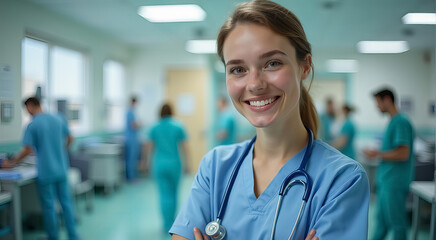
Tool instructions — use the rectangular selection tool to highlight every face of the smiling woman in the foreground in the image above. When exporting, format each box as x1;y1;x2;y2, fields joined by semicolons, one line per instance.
223;23;311;127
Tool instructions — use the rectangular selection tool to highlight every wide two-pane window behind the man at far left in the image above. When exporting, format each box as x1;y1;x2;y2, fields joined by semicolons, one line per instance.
22;38;89;134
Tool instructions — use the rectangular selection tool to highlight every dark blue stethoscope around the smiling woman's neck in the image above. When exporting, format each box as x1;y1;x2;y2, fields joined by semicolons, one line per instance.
206;128;313;240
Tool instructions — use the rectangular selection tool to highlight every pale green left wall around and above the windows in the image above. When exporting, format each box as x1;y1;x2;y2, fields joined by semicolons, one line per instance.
0;0;132;143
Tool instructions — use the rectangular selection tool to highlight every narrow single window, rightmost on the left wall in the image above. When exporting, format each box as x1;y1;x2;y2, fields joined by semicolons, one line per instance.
103;60;126;130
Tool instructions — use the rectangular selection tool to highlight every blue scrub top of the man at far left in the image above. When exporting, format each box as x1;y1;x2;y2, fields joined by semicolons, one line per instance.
23;113;70;182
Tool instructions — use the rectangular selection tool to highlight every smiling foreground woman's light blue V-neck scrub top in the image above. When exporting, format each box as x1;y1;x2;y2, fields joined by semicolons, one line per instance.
170;140;369;240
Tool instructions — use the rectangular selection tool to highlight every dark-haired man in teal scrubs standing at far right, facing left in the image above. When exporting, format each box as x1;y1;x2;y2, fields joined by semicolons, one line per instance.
364;89;415;240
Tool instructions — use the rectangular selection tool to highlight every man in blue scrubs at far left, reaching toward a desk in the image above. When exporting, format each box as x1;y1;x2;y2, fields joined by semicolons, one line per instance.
2;97;78;240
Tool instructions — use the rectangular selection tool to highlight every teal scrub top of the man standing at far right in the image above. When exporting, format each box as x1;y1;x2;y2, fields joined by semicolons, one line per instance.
377;113;415;187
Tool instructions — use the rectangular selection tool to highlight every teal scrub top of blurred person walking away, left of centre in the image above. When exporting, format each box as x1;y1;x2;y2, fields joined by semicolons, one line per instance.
149;117;186;164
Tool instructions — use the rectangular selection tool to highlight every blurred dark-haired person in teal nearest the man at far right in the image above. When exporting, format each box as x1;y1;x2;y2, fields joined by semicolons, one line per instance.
332;104;356;159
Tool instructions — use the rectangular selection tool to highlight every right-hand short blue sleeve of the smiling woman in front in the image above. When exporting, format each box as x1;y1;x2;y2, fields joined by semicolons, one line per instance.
309;167;370;240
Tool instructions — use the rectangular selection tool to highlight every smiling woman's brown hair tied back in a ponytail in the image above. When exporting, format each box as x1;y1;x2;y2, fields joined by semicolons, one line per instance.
217;0;318;138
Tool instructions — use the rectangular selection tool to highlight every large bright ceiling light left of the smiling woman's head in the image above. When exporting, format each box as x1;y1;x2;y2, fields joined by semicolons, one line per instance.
138;4;206;22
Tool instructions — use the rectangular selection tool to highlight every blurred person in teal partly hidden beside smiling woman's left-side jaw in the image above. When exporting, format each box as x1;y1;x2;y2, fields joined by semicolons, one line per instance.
217;97;236;145
